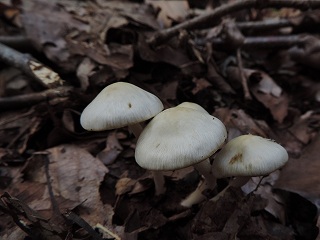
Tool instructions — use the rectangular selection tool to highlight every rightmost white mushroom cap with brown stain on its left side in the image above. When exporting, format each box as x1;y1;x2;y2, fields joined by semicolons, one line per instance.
212;135;288;178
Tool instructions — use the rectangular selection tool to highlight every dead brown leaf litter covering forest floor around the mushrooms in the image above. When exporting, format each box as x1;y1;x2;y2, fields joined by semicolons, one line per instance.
0;0;320;240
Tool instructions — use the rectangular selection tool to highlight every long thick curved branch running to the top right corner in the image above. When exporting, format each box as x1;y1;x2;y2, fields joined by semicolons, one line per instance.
148;0;320;47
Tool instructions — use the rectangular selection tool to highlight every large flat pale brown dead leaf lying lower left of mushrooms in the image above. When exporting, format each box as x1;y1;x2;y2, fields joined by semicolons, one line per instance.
20;145;113;227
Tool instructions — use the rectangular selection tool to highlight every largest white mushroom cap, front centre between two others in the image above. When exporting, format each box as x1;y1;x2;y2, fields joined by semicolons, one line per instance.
135;106;227;170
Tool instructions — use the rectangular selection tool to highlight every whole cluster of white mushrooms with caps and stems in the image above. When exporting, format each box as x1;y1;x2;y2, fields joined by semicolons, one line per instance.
80;82;288;207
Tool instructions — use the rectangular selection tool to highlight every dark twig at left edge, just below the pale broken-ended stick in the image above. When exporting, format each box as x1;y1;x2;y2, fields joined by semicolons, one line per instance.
0;87;72;110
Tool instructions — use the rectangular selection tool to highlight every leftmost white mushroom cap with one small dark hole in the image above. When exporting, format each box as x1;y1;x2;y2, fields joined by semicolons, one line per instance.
80;82;163;131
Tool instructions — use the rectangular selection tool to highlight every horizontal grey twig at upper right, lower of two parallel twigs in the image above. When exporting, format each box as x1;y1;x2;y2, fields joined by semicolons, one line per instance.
207;34;304;49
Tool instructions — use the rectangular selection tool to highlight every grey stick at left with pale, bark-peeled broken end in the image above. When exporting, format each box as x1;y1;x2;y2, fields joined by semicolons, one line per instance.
0;43;63;88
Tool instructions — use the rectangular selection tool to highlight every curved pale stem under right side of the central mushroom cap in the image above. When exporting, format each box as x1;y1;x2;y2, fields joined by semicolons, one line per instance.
180;159;216;207
